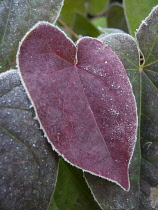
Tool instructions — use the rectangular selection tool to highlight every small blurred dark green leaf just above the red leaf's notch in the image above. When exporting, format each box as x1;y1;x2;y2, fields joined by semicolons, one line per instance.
73;13;100;37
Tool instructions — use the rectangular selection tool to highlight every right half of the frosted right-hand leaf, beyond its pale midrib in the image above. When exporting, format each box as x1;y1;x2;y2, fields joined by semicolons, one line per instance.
136;6;158;209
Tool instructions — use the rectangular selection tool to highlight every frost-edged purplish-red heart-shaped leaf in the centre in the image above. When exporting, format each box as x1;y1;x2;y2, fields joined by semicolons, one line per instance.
18;22;137;190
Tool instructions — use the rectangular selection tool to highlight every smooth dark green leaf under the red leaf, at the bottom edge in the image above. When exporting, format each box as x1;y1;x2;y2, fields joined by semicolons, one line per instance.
48;159;100;210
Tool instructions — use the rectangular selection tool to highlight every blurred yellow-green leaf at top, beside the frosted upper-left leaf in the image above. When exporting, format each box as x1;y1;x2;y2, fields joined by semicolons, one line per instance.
60;0;86;27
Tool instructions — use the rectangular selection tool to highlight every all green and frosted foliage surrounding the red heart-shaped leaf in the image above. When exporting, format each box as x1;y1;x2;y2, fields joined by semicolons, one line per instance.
0;0;158;210
